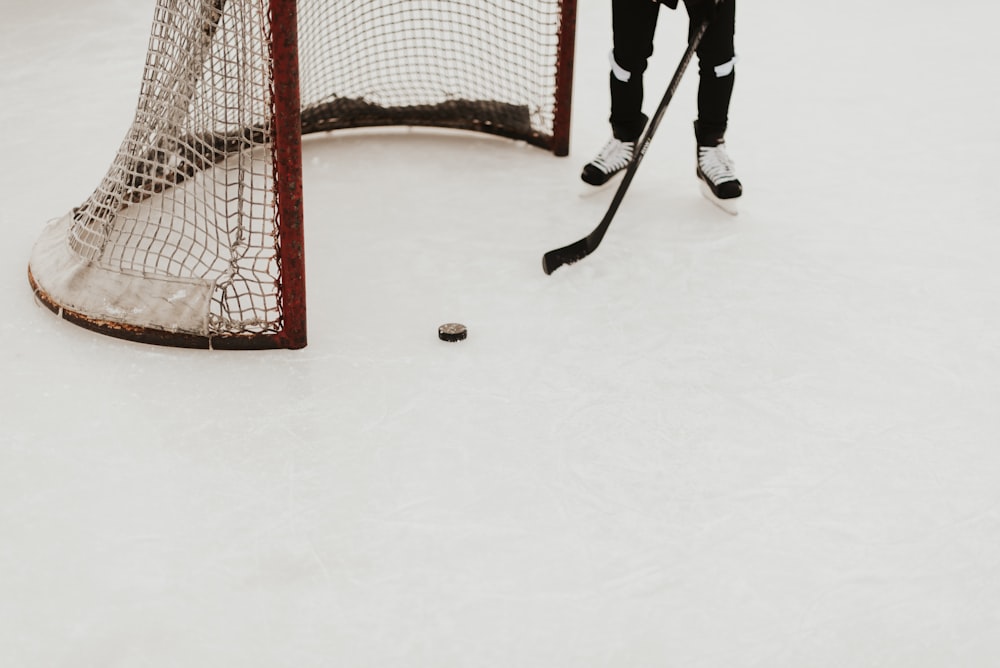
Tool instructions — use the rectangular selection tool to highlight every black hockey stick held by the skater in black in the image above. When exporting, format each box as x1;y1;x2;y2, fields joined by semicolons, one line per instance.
542;17;711;274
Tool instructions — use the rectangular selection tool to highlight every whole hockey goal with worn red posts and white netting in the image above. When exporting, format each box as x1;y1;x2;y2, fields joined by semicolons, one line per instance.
29;0;575;348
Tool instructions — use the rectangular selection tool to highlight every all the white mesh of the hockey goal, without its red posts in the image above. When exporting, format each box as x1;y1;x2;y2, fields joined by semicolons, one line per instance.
33;0;563;348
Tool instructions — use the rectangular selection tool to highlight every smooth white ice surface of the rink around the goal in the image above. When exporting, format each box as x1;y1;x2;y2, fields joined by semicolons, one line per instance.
0;0;1000;668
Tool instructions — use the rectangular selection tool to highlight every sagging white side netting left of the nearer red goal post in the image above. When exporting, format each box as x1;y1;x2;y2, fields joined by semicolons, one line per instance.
64;0;280;334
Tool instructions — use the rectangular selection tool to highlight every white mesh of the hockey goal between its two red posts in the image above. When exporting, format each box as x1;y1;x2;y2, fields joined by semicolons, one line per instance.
300;0;560;141
